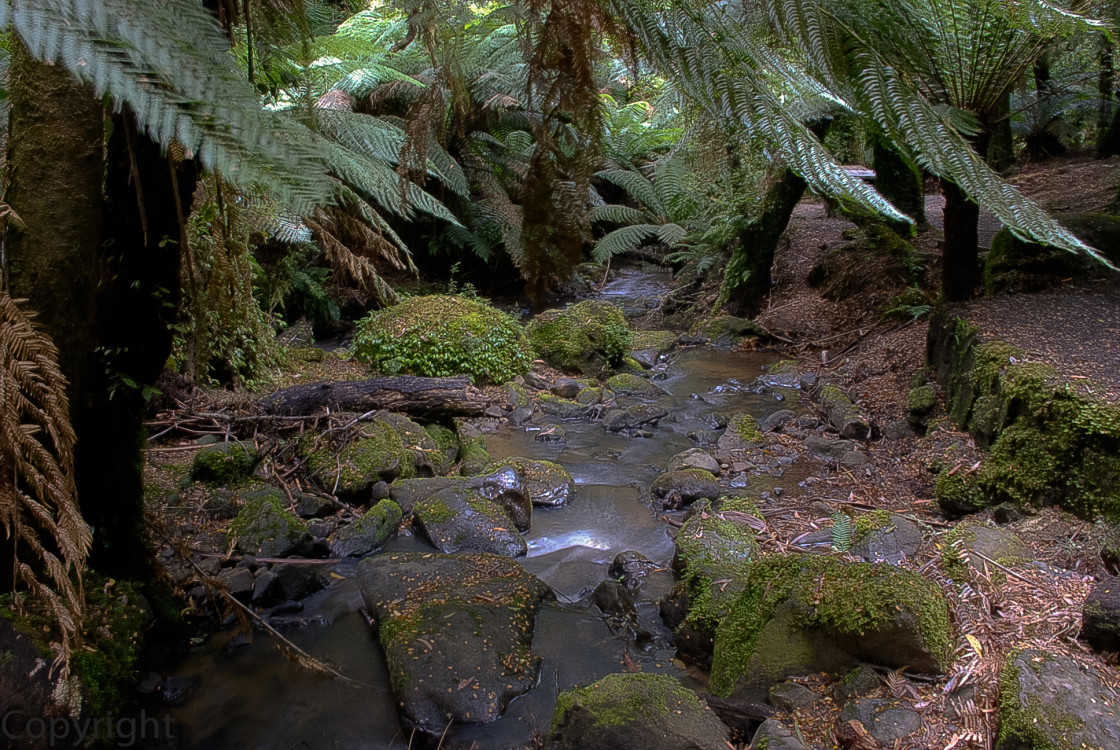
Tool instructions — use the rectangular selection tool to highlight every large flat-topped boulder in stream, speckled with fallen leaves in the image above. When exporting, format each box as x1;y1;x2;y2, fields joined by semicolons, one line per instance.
357;553;551;734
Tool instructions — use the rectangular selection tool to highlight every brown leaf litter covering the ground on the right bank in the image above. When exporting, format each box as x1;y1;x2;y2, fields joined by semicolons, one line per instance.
734;158;1120;749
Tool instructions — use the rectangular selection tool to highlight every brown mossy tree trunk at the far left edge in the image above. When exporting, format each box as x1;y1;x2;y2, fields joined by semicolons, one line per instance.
7;39;104;405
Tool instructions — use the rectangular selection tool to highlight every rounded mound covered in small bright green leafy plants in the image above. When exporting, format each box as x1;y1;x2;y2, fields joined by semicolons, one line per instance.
354;294;532;384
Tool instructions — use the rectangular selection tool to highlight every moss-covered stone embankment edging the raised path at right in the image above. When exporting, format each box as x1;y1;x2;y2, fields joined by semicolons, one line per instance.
927;308;1120;521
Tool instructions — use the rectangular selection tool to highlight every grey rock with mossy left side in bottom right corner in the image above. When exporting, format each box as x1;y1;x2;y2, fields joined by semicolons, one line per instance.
996;649;1120;750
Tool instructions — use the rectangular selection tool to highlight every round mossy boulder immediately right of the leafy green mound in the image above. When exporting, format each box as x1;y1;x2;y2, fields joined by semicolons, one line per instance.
529;300;631;377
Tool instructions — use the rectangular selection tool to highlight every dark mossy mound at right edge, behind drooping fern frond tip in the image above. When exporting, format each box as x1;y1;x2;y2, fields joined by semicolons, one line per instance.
983;213;1120;296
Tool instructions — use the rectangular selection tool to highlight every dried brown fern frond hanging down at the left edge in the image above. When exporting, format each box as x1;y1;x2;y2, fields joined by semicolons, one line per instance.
0;291;91;663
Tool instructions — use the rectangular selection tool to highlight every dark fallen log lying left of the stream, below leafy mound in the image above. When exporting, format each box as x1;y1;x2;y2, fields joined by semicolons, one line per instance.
261;375;489;416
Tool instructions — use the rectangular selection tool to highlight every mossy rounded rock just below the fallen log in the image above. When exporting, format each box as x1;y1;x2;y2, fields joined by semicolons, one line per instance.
300;412;437;504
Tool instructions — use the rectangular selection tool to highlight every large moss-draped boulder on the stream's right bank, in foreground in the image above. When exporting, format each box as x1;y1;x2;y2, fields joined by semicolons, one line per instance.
711;555;952;700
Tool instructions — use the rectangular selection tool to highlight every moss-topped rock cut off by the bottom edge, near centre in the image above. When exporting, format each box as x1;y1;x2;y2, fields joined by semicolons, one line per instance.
544;674;728;750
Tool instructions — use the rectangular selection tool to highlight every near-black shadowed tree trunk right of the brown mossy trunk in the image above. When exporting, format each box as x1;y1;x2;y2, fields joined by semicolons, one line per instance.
76;106;197;580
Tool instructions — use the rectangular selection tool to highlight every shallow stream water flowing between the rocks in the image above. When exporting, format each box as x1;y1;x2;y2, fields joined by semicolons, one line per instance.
162;273;797;750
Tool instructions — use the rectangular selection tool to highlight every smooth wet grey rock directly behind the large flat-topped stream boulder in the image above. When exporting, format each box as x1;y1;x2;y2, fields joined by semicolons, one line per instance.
412;486;532;557
